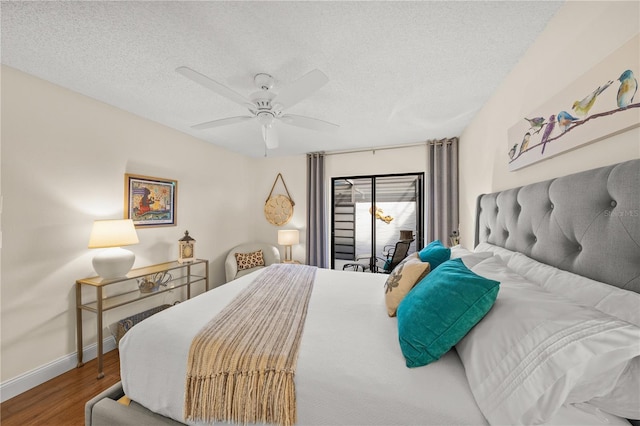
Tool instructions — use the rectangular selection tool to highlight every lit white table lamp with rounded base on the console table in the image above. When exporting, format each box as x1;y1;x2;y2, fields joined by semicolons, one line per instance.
89;219;139;280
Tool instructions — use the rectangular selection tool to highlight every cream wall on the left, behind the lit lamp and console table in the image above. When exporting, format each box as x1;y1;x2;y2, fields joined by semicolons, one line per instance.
0;67;260;383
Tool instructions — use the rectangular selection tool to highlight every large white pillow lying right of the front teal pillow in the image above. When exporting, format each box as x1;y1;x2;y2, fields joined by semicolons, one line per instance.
456;256;640;424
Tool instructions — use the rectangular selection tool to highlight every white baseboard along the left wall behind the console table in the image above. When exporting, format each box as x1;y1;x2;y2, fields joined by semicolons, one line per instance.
0;336;116;402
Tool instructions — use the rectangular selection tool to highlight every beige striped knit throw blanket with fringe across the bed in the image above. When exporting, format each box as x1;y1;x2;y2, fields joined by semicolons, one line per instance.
184;264;316;425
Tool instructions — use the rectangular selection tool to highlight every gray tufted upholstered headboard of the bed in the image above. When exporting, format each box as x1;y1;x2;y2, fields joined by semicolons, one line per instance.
475;160;640;293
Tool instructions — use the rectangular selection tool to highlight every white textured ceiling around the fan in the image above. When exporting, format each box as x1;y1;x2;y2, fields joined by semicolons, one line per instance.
1;1;561;157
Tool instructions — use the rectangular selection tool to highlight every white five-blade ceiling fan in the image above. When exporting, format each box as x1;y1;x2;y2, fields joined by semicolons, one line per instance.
176;67;339;149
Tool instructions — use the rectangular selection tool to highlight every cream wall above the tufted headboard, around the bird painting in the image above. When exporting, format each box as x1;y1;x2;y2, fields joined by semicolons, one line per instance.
460;1;640;247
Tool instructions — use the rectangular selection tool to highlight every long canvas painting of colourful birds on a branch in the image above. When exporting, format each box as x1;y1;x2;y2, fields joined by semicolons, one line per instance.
505;35;640;172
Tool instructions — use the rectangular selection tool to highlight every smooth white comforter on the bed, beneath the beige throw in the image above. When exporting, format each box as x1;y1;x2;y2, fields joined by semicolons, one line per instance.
120;269;486;425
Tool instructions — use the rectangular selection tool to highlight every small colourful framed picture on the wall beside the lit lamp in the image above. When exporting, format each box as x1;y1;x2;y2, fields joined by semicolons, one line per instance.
124;173;178;227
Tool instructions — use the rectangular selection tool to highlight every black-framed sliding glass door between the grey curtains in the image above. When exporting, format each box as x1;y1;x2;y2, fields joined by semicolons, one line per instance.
331;173;424;270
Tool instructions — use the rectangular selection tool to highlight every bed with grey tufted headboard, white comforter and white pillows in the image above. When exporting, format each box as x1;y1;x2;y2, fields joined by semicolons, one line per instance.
86;160;640;425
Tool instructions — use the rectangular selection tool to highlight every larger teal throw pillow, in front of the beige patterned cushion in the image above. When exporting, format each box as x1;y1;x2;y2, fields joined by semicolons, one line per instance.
397;259;500;367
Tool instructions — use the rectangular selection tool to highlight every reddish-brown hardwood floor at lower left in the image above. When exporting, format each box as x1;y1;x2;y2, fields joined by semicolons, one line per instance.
0;349;120;426
